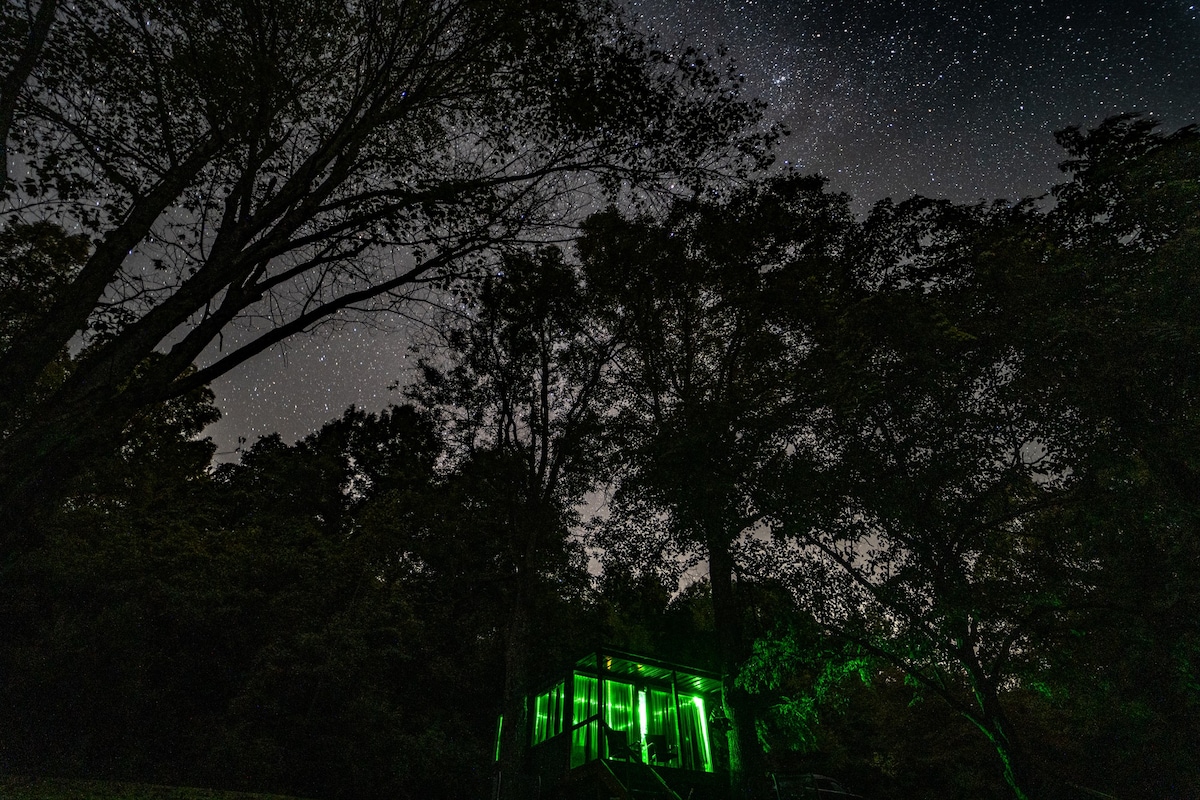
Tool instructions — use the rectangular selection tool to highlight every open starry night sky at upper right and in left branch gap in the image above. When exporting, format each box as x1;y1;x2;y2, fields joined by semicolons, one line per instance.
206;0;1200;458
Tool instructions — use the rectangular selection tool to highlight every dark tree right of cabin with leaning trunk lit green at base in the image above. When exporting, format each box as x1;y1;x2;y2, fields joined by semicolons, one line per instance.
761;208;1086;798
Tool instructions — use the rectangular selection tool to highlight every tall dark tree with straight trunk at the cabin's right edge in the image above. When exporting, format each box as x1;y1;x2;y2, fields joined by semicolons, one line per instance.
580;175;851;796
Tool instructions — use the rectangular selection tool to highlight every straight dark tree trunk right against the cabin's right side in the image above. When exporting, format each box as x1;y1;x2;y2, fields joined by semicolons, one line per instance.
708;537;764;800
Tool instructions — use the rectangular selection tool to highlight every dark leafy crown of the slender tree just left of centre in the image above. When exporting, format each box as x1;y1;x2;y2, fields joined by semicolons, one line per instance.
407;247;618;510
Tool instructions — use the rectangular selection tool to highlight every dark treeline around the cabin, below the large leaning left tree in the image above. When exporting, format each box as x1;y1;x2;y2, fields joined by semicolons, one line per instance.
0;116;1200;799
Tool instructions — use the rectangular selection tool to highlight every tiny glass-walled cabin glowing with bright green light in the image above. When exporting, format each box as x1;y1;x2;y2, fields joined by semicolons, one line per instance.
497;649;728;800
